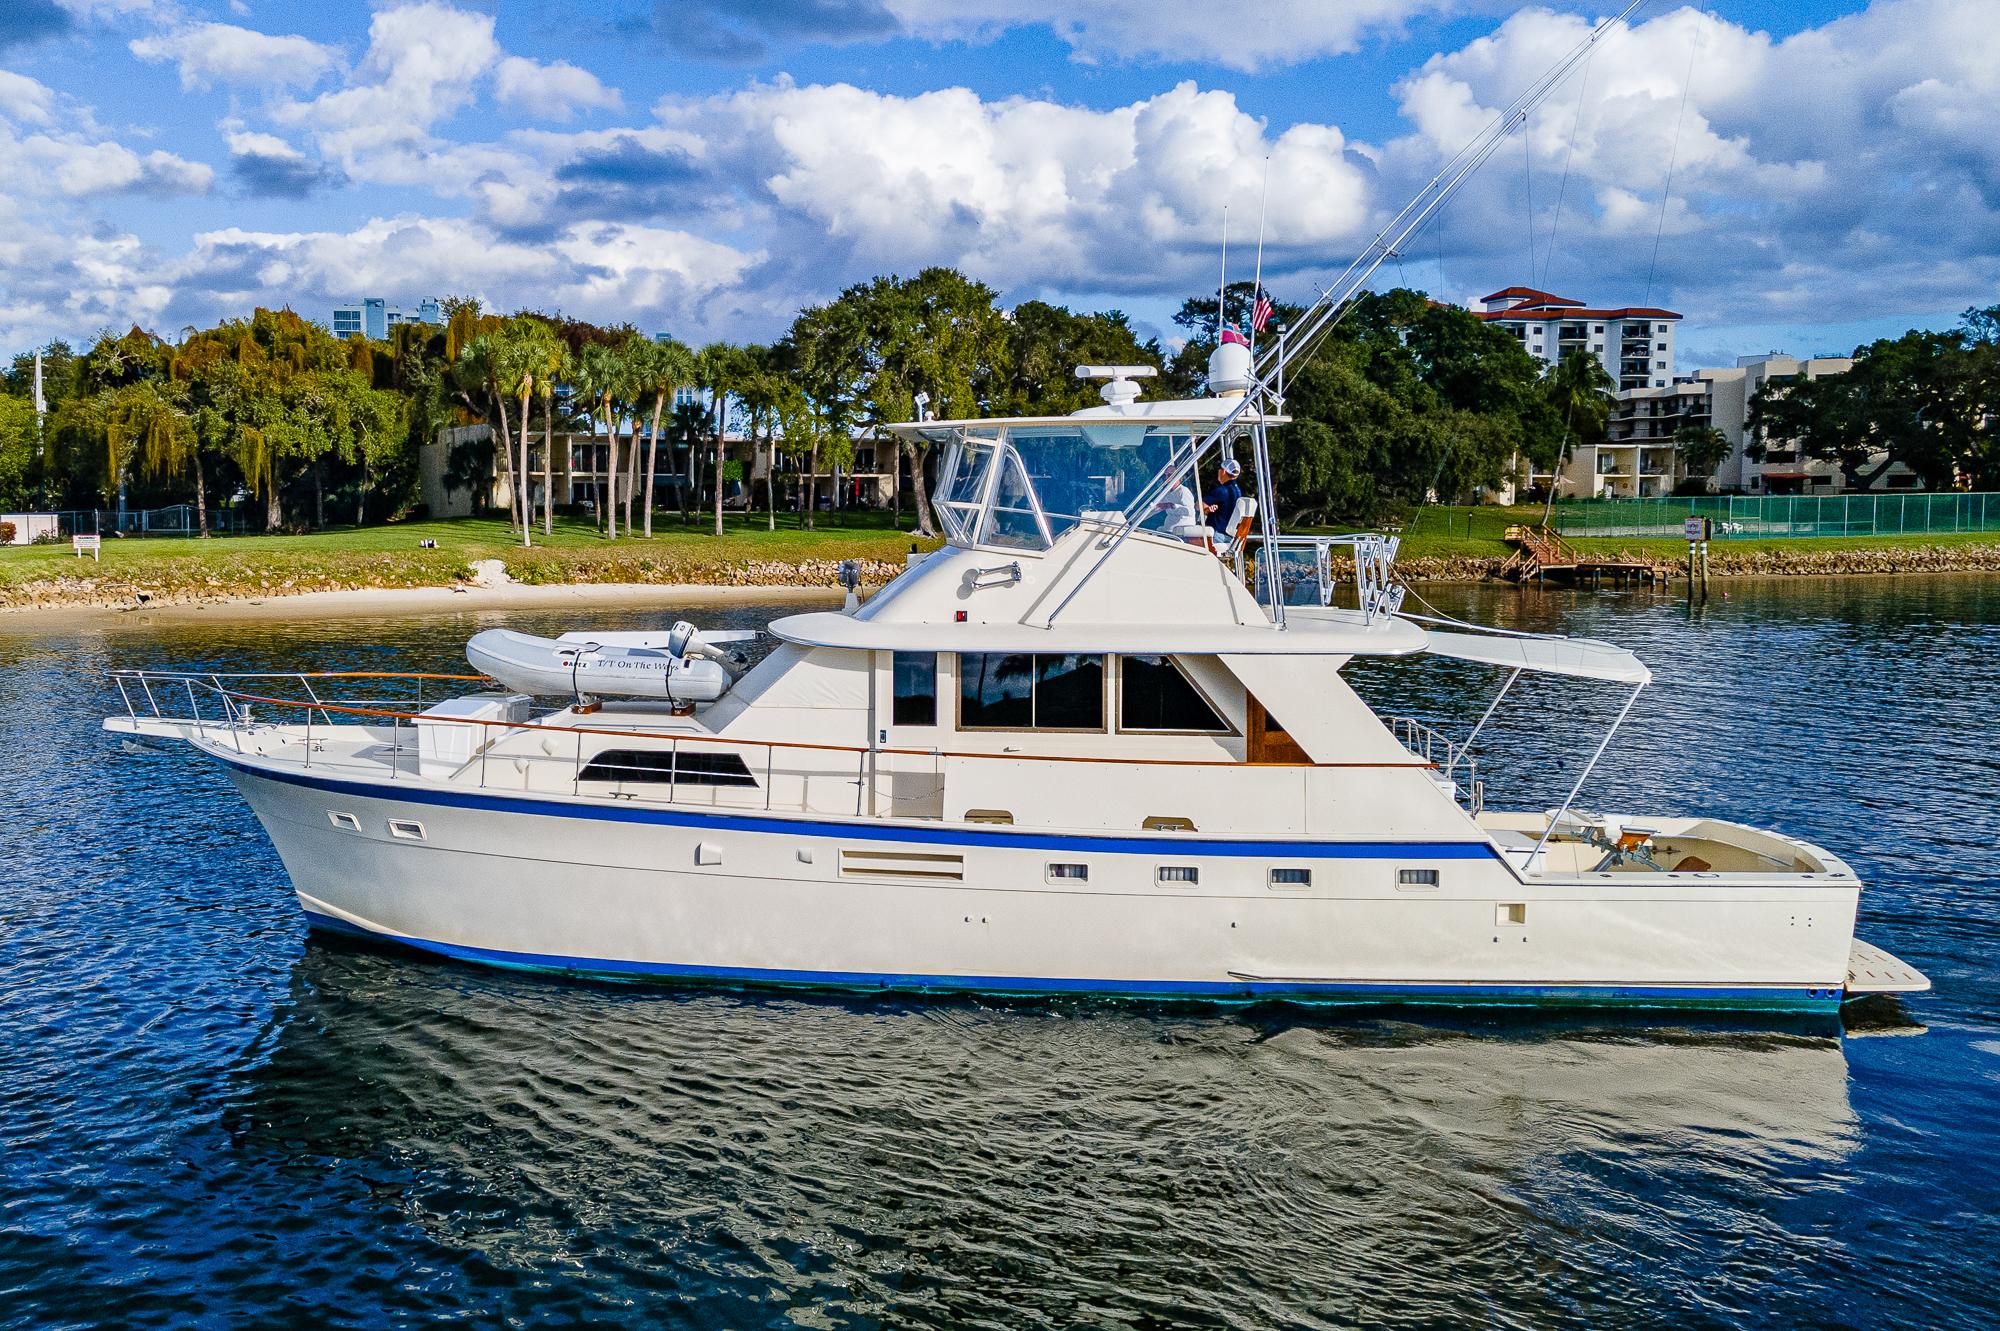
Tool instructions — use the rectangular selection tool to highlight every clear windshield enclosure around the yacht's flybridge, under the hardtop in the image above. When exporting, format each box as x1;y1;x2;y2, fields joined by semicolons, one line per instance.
938;422;1210;550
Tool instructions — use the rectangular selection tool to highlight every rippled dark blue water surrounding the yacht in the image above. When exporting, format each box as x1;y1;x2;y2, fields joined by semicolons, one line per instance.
0;580;2000;1327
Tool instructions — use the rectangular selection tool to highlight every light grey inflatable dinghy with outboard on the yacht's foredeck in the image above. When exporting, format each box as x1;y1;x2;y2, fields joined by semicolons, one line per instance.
466;620;756;703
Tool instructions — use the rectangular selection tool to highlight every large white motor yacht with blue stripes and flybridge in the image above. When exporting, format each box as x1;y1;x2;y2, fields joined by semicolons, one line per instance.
106;346;1928;1011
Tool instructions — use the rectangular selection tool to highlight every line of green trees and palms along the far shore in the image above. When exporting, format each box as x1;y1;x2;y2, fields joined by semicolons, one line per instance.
15;268;1976;542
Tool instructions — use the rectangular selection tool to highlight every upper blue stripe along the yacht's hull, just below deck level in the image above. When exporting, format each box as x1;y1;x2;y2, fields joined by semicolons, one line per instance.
220;757;1502;859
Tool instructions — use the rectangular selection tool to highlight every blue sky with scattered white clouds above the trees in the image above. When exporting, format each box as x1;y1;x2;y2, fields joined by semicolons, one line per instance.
0;0;2000;364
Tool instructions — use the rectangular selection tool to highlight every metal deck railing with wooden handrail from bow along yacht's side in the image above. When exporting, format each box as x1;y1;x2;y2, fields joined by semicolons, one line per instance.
106;669;1436;817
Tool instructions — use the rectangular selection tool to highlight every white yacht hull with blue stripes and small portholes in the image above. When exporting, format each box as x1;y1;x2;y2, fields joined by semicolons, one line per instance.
230;753;1858;1011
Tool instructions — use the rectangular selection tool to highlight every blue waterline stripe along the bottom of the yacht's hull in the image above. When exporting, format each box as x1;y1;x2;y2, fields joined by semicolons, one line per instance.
306;909;1840;1011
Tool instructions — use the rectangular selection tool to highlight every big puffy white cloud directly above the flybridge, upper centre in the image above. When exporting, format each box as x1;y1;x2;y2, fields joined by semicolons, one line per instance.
640;84;1368;290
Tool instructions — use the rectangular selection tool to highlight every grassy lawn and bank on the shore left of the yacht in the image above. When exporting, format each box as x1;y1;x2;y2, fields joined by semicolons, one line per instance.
0;512;934;596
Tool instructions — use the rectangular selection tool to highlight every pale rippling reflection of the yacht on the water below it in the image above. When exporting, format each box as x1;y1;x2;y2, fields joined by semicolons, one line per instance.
224;943;1858;1325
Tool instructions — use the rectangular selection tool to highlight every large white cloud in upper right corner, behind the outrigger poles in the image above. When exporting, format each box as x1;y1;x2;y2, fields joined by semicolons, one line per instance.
1382;0;2000;322
